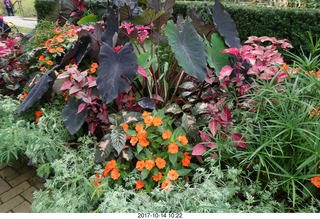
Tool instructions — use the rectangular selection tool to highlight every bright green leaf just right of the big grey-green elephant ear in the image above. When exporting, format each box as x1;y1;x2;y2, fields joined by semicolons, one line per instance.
205;33;232;76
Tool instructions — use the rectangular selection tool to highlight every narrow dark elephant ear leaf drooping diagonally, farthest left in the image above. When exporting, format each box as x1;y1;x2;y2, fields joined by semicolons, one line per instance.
17;68;57;114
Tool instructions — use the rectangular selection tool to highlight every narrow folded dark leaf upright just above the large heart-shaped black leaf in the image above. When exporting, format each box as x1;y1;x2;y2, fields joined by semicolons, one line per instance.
101;8;119;47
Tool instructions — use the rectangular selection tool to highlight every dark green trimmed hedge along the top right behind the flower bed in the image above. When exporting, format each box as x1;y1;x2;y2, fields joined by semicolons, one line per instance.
174;1;320;52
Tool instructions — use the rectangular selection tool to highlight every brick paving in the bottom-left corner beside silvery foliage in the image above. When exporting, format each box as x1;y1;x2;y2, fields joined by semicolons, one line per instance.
0;161;43;213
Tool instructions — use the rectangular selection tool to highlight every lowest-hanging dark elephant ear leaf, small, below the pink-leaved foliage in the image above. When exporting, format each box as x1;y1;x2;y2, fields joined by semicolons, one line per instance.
61;98;87;135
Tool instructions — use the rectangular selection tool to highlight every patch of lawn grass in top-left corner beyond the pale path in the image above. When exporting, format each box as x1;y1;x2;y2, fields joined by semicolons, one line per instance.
0;0;37;17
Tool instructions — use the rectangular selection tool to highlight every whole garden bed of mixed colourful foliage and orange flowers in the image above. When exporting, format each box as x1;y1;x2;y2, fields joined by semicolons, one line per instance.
0;0;320;213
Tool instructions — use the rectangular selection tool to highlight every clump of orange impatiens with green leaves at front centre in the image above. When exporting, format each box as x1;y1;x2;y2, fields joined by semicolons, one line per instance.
94;110;196;191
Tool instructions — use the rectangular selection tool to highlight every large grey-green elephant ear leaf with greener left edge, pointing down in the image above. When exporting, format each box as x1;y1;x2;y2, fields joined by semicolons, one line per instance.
165;19;207;82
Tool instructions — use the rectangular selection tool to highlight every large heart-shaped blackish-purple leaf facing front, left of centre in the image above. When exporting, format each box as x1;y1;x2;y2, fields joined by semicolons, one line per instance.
97;43;138;104
